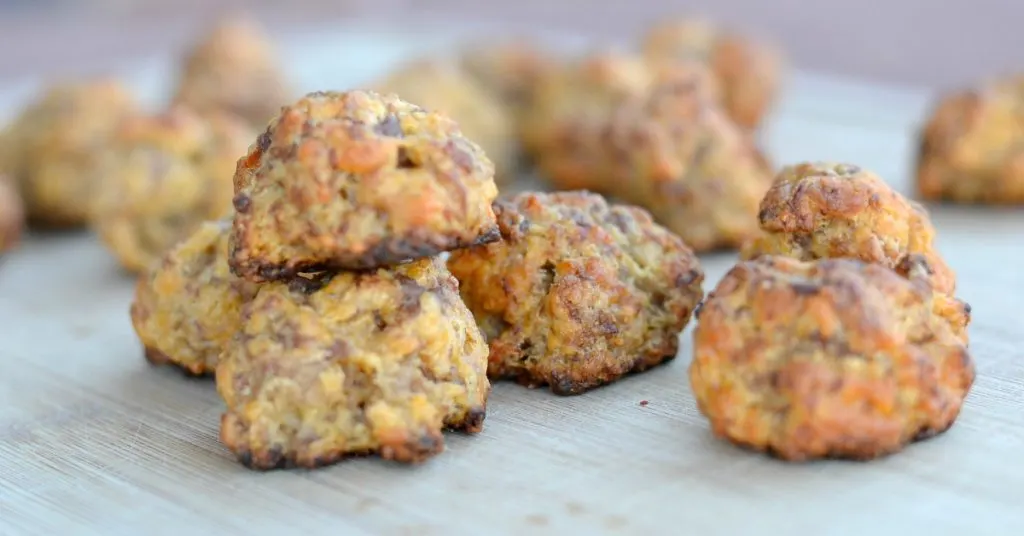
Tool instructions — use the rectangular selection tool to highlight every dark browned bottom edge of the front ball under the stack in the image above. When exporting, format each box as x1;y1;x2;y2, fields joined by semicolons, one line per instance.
220;407;486;471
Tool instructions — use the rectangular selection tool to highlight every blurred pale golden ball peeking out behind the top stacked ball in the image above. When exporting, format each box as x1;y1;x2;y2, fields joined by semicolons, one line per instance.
373;59;518;182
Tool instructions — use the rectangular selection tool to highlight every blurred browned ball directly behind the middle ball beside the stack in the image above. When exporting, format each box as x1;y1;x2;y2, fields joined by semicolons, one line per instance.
604;66;773;251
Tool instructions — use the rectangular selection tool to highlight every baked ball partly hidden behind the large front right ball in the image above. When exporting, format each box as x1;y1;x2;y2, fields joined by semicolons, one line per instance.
741;162;956;293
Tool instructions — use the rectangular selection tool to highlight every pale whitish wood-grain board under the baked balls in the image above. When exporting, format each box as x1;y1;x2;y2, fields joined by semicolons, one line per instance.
0;22;1024;535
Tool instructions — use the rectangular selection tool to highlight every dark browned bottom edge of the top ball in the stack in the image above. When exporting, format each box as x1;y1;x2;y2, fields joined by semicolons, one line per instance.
229;225;501;283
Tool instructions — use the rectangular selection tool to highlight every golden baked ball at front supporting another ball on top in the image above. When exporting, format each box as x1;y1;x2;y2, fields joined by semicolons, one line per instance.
217;257;490;469
